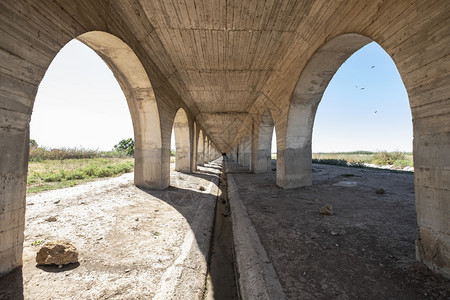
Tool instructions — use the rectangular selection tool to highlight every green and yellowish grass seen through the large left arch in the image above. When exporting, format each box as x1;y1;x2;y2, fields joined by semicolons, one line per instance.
27;157;134;193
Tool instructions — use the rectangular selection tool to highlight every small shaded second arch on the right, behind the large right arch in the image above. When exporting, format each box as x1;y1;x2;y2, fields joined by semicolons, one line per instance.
253;109;275;173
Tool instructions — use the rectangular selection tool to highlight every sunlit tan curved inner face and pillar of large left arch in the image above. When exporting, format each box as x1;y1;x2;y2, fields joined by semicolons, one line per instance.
77;31;168;189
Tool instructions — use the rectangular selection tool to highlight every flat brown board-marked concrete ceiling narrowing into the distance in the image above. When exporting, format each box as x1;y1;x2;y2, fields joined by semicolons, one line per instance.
123;0;314;151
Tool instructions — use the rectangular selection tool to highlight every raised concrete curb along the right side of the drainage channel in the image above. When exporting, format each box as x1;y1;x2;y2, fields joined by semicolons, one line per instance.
225;161;286;299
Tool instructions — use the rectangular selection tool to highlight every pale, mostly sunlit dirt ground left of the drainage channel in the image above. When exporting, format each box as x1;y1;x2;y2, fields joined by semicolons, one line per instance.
0;161;221;299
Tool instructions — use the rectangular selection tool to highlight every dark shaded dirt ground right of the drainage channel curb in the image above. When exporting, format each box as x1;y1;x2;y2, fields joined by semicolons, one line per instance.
232;164;450;299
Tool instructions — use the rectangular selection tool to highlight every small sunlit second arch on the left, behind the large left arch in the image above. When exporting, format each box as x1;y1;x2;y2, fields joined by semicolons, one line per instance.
173;108;191;173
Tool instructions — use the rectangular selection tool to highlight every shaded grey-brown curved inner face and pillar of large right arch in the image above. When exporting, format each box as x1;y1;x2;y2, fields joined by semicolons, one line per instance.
277;34;372;188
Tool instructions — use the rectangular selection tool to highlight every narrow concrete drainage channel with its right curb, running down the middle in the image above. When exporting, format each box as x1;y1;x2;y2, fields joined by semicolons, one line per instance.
204;158;286;300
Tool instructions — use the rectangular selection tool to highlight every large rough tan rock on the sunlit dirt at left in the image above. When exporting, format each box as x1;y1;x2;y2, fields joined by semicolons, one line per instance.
36;241;78;266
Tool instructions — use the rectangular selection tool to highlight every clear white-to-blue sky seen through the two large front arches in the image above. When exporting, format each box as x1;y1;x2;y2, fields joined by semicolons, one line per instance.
30;40;412;152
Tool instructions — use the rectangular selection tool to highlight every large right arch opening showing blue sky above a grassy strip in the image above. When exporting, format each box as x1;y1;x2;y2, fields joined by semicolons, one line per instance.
312;42;412;167
